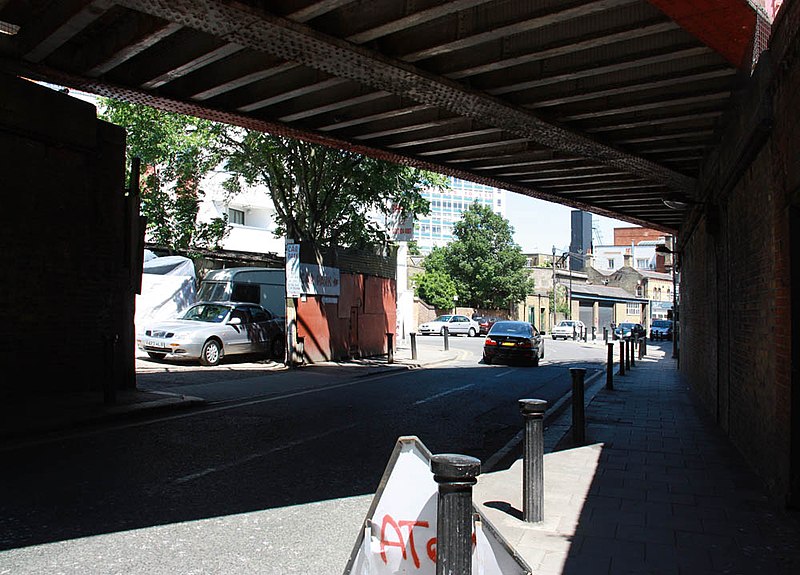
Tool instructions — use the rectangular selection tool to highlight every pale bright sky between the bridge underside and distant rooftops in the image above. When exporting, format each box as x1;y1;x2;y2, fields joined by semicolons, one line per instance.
505;192;635;254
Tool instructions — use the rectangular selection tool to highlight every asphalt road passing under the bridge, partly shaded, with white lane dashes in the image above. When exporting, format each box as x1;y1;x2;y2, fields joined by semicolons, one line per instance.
0;336;605;573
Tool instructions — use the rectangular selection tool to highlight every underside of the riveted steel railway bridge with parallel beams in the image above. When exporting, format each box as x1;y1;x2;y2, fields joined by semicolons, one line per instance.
0;0;769;233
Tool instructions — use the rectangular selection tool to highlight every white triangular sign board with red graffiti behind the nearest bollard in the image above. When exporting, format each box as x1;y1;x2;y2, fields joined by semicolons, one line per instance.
344;436;531;575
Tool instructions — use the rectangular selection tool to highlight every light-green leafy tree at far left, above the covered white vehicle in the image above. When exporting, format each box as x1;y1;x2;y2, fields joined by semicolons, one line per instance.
100;98;227;250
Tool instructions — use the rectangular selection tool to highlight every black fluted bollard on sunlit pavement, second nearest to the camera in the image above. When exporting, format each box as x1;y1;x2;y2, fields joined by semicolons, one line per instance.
519;399;547;523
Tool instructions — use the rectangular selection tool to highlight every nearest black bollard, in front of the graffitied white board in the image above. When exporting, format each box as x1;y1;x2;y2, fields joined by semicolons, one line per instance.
431;453;481;575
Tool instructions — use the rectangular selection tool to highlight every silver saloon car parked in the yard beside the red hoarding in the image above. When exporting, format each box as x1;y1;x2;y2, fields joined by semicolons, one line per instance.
137;302;285;365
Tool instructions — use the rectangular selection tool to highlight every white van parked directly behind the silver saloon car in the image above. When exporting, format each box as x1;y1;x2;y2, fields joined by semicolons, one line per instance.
197;268;286;317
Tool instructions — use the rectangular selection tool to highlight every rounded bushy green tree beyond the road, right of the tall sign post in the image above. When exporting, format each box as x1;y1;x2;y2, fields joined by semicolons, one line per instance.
423;203;533;309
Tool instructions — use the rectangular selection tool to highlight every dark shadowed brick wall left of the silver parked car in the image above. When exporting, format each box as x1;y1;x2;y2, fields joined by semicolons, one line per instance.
0;74;134;396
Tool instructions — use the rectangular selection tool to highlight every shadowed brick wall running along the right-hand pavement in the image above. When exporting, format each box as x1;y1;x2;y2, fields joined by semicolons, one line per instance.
680;3;800;502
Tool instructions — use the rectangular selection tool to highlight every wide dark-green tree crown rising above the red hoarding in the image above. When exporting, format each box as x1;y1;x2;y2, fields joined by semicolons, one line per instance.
226;131;445;258
